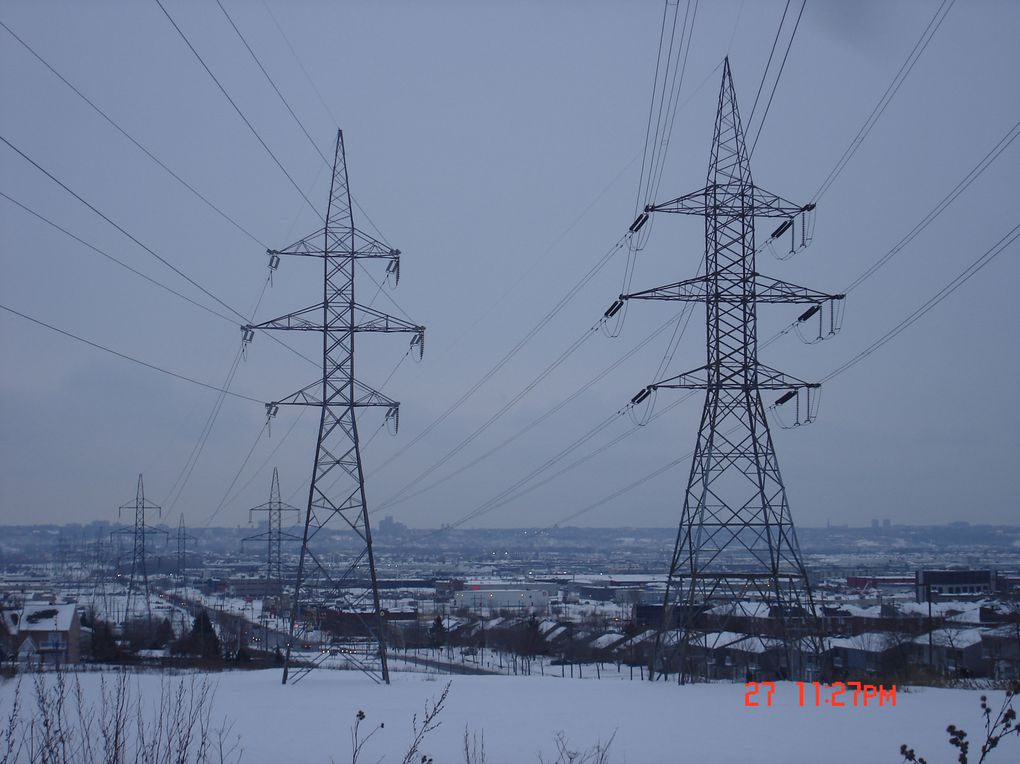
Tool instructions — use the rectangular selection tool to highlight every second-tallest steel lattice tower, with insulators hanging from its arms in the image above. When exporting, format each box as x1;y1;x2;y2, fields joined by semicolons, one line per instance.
243;131;425;683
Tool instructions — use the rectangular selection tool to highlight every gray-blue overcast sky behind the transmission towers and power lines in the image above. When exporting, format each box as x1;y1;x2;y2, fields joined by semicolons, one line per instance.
0;0;1020;526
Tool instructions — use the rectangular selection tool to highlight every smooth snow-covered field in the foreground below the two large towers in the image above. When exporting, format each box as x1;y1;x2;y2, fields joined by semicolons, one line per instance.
0;670;1003;764
